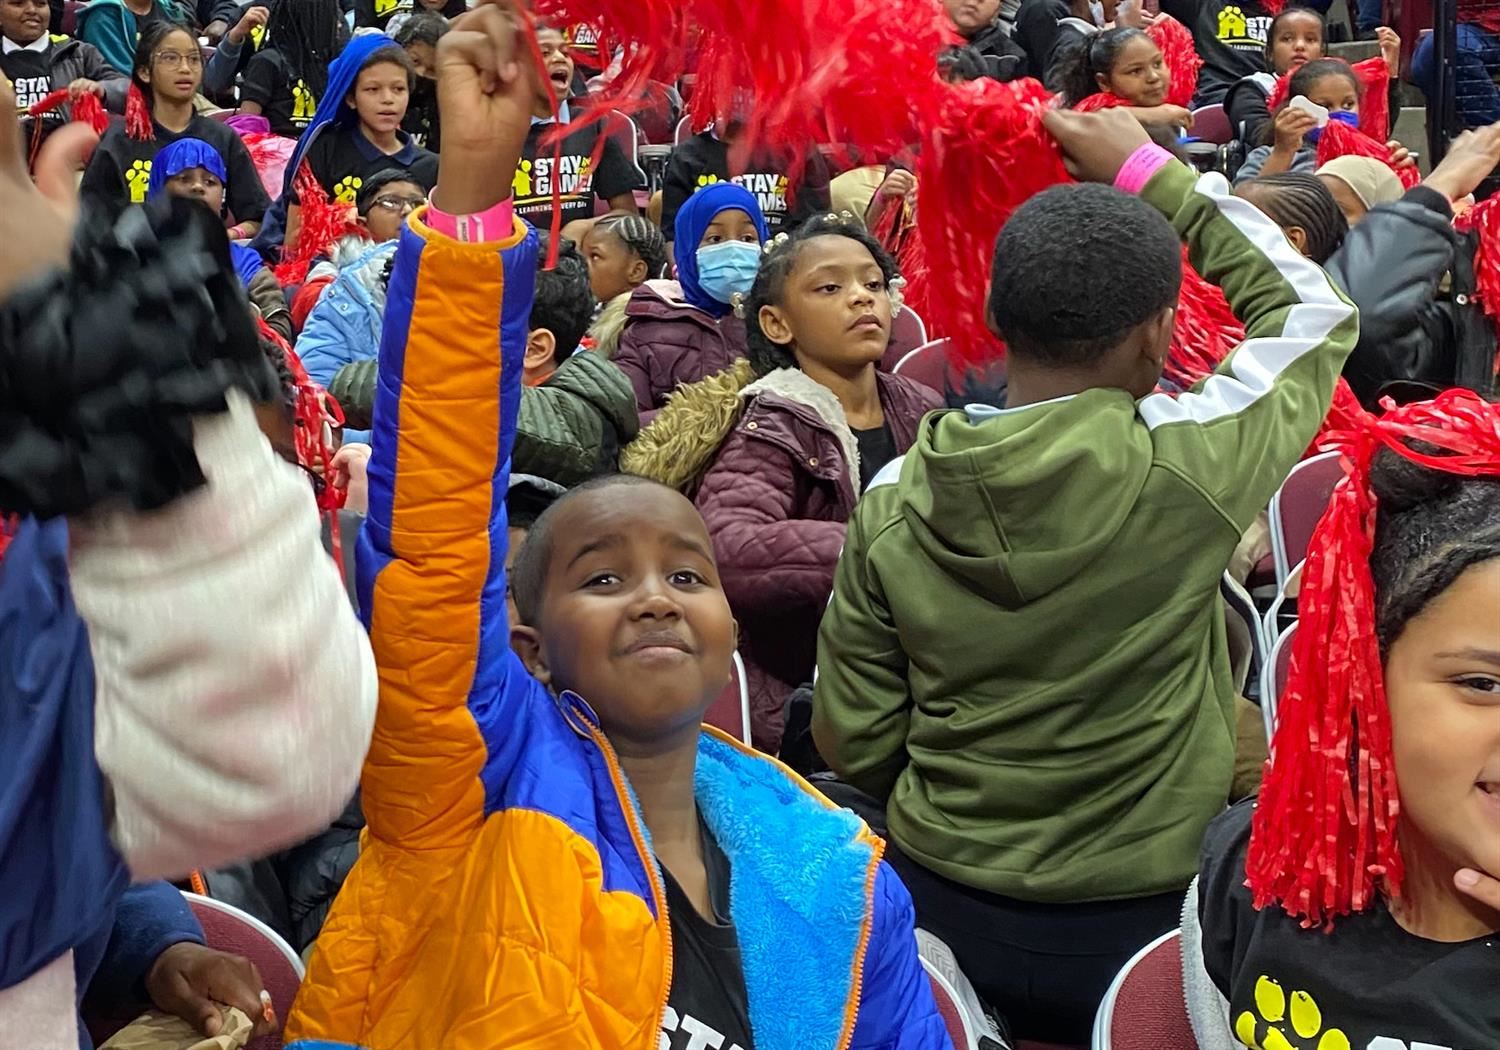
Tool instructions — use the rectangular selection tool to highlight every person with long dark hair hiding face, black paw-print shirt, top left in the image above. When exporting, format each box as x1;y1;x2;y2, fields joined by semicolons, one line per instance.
240;0;348;138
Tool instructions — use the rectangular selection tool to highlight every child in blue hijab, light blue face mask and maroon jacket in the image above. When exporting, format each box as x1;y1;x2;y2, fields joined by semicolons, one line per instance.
614;183;767;422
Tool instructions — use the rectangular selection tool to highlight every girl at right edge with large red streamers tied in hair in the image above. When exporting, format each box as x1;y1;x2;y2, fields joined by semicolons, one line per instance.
1182;390;1500;1050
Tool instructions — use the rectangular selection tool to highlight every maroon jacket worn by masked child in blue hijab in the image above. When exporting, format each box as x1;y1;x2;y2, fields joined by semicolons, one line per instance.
612;281;746;423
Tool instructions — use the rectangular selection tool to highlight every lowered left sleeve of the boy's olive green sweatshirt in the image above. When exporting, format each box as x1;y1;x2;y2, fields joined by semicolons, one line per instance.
813;486;912;800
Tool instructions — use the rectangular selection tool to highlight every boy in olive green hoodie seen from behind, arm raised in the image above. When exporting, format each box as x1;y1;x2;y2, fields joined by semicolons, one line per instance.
813;113;1356;1040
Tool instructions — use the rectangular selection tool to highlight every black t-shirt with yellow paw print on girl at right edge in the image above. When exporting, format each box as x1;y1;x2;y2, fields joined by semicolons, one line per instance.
1199;803;1500;1050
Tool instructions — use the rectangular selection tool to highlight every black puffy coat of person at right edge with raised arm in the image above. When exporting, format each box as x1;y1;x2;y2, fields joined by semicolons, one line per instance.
1323;186;1496;407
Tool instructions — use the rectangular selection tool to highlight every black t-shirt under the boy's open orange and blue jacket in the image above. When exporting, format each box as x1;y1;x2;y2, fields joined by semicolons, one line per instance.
662;816;755;1050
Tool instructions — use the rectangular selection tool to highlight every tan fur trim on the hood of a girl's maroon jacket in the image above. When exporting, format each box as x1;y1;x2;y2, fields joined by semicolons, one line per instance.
620;359;755;492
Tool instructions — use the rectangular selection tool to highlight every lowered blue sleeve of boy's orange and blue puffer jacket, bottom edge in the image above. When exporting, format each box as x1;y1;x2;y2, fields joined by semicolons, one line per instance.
851;861;953;1050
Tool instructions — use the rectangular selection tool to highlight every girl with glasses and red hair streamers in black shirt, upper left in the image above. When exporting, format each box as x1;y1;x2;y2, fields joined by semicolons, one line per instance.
80;23;269;237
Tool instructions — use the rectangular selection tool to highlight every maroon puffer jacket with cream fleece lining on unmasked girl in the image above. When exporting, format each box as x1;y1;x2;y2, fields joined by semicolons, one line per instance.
696;369;942;755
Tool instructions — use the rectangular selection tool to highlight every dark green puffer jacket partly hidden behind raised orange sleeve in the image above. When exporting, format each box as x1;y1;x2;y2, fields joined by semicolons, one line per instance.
329;350;641;488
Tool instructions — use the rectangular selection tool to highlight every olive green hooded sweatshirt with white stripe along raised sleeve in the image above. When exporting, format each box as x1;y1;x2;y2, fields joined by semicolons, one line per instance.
813;162;1359;903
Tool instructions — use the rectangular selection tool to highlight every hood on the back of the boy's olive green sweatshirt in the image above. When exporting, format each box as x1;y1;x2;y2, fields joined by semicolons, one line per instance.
902;390;1152;609
